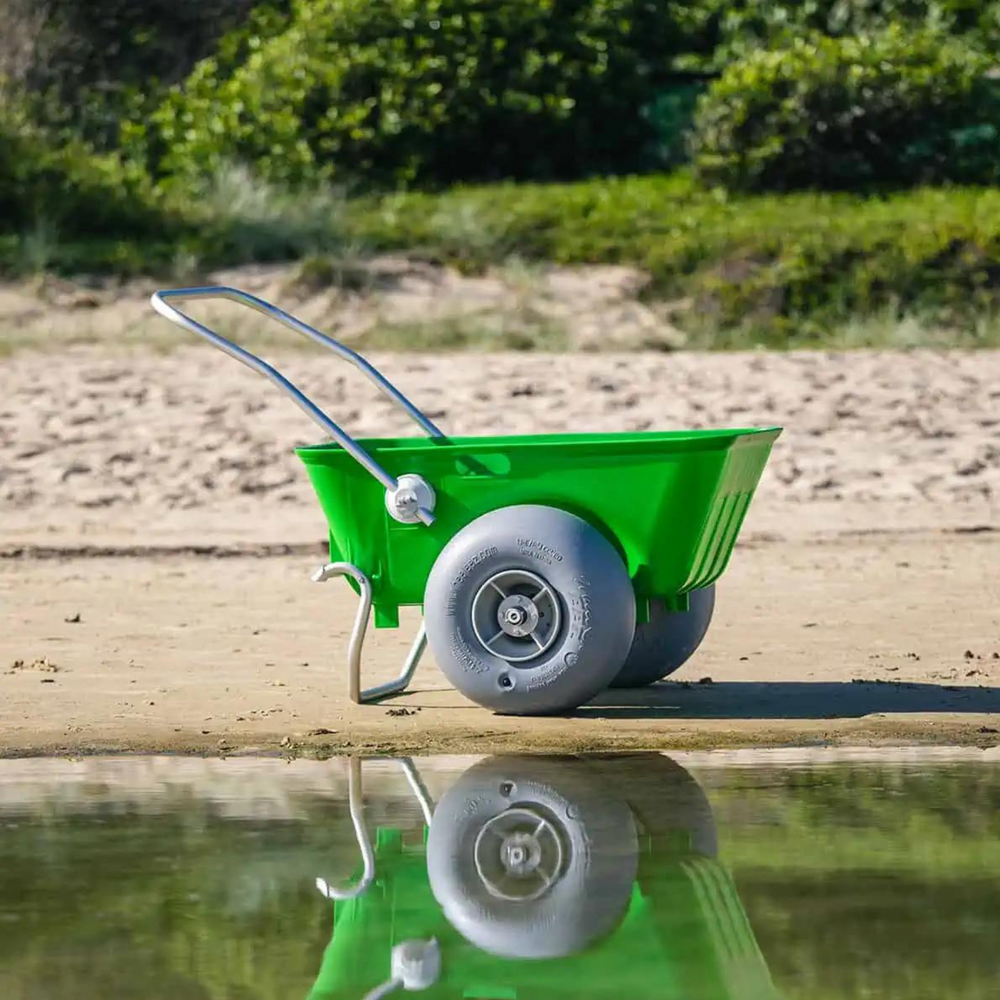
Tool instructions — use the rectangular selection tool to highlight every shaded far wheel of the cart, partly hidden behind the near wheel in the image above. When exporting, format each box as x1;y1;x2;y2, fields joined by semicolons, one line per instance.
611;583;715;687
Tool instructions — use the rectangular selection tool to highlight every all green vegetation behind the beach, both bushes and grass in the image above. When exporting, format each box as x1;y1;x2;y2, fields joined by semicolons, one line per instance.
0;0;1000;347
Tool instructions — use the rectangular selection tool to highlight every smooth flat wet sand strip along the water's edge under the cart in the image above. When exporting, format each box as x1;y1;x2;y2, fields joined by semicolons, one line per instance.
0;531;1000;755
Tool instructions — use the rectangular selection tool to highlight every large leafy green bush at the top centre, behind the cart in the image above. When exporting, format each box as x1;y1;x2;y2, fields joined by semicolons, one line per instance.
145;0;704;186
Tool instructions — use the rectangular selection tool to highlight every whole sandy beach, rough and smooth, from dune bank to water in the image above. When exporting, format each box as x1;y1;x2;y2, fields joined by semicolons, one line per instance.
0;346;1000;755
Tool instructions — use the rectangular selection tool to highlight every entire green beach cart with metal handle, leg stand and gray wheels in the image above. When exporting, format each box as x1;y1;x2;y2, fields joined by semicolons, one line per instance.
153;288;780;714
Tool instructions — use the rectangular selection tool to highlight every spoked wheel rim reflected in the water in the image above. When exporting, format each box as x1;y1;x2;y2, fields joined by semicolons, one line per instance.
474;806;564;903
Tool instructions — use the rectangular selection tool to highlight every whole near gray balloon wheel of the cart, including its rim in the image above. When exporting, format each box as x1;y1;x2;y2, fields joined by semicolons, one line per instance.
424;505;635;715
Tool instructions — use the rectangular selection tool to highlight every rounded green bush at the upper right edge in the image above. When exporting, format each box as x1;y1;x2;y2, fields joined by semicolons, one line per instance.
693;28;1000;191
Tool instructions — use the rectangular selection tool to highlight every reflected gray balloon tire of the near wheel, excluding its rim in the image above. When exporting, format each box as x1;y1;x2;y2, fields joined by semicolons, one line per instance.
427;756;639;959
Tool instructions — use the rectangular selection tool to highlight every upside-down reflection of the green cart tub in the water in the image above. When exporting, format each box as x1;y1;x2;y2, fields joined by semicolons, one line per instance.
309;828;776;1000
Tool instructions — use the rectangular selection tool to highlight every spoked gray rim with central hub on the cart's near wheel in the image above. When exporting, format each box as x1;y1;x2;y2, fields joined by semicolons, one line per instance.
472;569;562;663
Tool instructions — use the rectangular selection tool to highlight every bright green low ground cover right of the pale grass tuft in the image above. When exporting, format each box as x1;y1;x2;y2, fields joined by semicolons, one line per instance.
345;173;1000;347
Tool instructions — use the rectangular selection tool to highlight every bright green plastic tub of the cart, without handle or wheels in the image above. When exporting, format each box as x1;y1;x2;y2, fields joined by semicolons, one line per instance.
298;428;780;625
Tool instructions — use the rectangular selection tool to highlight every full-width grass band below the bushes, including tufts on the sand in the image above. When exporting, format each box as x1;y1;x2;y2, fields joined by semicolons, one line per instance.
0;167;1000;349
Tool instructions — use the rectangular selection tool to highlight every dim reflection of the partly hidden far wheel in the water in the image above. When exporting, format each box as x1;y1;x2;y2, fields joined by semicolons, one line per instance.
588;753;719;858
